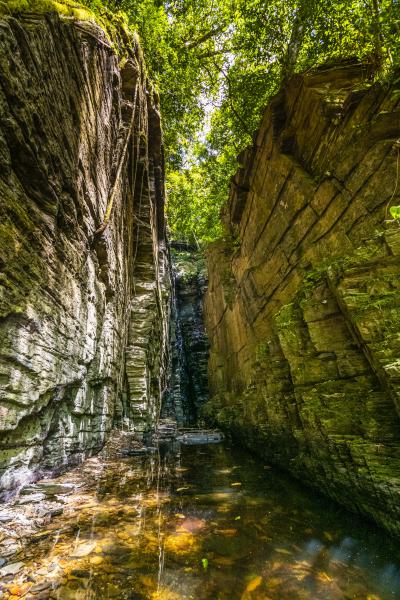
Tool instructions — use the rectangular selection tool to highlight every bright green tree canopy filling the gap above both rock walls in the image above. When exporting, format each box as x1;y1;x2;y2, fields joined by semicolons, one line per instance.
86;0;400;243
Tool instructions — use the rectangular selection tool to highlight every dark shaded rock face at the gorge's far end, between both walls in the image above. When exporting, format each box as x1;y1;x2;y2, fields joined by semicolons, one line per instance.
163;243;208;425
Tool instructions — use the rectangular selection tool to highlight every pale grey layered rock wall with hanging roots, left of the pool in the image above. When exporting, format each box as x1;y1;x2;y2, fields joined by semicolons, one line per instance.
0;14;169;490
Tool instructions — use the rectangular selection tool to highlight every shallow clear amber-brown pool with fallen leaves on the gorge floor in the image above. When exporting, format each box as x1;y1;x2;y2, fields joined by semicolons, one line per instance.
4;444;400;600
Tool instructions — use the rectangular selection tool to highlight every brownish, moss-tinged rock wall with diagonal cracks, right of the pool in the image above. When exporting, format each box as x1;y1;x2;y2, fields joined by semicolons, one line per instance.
206;63;400;534
